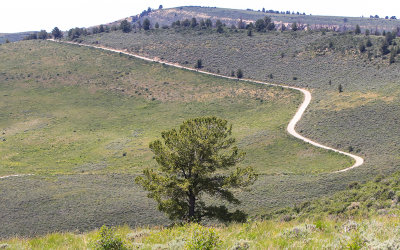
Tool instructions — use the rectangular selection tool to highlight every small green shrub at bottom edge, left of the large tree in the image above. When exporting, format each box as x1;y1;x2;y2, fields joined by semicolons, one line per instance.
94;225;126;250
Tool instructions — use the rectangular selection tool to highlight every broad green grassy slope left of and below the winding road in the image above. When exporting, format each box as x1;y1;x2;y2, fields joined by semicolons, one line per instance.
0;41;351;237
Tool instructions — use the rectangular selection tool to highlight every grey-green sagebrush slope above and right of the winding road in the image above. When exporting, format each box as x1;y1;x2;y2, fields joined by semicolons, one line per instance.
79;26;400;178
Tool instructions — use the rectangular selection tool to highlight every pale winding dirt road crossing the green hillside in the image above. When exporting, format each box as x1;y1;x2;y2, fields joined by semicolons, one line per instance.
39;39;364;173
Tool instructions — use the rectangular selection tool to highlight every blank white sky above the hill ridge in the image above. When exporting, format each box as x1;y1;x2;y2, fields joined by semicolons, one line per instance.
0;0;400;33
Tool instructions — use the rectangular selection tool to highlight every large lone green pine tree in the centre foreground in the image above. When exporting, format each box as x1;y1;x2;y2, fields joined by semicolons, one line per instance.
136;117;257;221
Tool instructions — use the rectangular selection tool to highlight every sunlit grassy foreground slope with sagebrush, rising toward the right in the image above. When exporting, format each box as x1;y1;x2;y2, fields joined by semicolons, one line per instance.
0;174;400;249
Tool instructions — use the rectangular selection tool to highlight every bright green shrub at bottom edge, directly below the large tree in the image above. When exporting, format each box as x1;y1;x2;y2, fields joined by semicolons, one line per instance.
185;224;221;250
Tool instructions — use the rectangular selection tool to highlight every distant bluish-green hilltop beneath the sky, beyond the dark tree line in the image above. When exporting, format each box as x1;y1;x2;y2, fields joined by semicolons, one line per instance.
134;6;400;31
